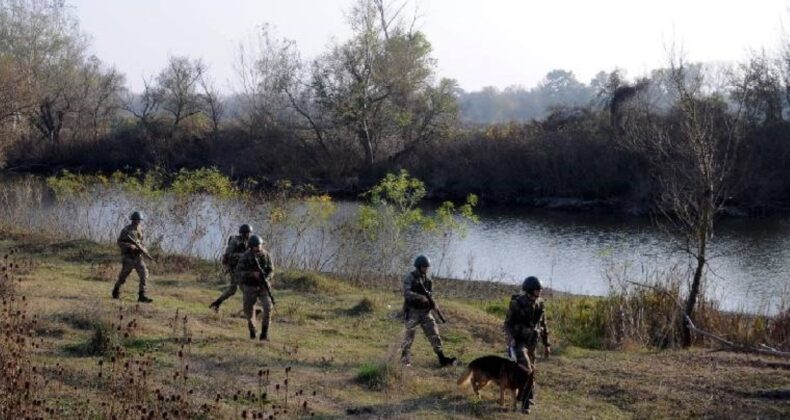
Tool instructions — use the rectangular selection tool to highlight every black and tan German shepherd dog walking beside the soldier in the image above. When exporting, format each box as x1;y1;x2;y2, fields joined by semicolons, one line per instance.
458;356;532;411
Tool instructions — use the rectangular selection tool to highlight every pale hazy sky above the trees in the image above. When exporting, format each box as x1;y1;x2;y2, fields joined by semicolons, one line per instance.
69;0;790;90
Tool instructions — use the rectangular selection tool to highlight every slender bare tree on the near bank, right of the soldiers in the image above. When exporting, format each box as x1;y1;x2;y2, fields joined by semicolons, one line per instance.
612;55;742;346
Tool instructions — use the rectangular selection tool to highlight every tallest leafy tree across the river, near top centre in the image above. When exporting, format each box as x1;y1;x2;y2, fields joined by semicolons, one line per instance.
300;0;457;168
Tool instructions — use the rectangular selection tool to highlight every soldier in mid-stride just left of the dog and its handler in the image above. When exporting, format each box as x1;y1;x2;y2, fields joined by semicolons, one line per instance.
401;255;456;367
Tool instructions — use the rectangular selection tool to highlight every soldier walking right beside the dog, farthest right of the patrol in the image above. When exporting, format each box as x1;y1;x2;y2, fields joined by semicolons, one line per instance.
505;276;551;413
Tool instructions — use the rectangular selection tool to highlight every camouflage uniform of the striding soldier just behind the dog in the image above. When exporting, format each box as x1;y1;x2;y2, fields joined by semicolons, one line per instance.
401;270;442;364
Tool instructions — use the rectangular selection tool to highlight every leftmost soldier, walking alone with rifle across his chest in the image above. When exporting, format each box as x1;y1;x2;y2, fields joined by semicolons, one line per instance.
112;211;153;303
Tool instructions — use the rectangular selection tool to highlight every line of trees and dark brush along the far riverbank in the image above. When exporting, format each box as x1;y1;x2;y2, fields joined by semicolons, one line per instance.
0;0;790;212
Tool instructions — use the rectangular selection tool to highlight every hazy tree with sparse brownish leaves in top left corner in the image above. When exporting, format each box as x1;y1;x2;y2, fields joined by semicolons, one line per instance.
0;0;123;144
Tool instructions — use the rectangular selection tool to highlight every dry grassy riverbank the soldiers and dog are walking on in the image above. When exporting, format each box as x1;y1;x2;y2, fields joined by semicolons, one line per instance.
0;234;790;418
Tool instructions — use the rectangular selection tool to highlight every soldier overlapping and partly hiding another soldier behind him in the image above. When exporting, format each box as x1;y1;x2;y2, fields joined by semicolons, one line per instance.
236;235;274;340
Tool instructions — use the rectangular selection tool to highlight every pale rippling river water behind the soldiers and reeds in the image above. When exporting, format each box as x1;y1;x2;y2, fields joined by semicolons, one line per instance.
7;184;790;313
